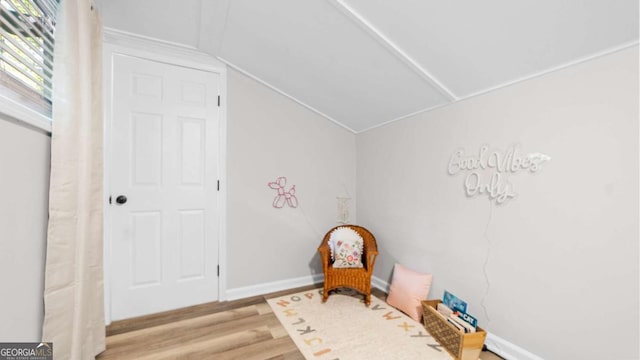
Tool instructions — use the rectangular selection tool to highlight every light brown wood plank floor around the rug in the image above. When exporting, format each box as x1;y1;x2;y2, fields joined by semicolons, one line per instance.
96;285;501;360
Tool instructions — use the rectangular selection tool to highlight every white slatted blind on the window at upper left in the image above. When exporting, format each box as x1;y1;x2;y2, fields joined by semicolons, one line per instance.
0;0;59;115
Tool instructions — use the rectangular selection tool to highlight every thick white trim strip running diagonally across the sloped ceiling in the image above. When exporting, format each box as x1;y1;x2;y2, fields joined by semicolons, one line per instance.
327;0;459;101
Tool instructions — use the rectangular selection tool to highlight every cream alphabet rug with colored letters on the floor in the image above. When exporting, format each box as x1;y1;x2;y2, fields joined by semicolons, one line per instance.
268;289;451;360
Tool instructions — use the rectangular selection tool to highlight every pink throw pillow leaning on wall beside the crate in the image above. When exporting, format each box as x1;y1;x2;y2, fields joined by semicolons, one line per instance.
387;264;433;322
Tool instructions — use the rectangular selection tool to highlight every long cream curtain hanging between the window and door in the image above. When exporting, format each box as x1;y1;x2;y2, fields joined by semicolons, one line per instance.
42;0;105;360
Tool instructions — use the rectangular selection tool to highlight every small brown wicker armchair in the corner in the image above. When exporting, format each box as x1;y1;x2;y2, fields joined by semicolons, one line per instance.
318;225;378;306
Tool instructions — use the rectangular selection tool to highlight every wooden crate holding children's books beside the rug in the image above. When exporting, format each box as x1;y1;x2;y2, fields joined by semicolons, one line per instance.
422;300;487;360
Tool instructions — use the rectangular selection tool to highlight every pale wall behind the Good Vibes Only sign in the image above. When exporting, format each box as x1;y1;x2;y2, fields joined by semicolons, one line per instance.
357;47;640;360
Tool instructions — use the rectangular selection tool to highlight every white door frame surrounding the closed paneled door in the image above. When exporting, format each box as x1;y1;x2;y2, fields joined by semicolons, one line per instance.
102;28;227;325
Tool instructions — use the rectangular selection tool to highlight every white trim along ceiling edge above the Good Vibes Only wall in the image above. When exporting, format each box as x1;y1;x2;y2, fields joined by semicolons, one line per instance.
356;40;640;135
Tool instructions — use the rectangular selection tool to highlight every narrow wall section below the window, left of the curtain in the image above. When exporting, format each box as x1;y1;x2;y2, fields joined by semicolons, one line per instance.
0;118;51;342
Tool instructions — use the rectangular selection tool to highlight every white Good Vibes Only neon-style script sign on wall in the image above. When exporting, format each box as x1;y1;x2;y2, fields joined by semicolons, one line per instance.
447;146;551;204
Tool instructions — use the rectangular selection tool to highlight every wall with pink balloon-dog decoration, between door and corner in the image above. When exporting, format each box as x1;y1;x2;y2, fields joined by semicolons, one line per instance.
227;69;356;292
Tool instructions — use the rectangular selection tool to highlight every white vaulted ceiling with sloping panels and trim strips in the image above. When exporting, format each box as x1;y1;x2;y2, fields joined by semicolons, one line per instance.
97;0;639;133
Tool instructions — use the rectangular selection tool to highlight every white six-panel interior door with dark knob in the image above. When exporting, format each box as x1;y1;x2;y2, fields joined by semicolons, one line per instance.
110;55;220;320
